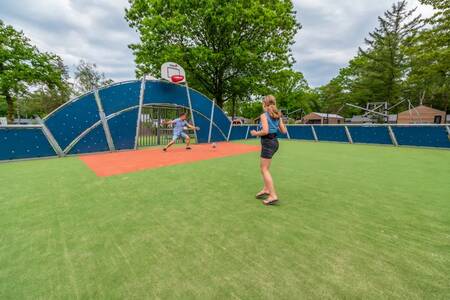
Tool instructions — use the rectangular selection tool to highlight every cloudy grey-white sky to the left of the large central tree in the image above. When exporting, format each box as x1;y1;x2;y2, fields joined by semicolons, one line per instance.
0;0;138;80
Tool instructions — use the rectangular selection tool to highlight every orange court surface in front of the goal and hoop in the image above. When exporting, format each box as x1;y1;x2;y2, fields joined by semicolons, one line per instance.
80;142;261;177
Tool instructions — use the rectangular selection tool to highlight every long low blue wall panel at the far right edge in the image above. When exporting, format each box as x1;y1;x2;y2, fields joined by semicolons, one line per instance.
392;126;450;148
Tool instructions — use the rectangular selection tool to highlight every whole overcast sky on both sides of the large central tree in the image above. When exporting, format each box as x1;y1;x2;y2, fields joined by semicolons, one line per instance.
0;0;432;86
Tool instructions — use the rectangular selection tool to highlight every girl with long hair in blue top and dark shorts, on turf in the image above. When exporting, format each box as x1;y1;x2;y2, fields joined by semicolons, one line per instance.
250;95;287;205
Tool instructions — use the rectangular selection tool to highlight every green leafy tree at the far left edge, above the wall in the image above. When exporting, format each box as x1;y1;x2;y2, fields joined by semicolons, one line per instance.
0;20;68;122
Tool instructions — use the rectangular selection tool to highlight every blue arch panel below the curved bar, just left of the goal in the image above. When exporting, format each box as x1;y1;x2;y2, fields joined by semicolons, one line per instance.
108;108;138;150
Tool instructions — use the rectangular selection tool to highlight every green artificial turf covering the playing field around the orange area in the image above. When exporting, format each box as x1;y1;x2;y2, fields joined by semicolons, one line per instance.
0;142;450;299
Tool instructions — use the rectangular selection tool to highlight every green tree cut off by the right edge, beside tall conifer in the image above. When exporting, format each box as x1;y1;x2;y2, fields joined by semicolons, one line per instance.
407;0;450;111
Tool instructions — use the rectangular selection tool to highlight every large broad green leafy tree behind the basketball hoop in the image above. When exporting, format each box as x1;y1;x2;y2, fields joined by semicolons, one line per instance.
126;0;300;107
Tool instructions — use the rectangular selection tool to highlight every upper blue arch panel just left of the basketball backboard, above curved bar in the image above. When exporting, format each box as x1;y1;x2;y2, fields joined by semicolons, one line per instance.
98;81;141;116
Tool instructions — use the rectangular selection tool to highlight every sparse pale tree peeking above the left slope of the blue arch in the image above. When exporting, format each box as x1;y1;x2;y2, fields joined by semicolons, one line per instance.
74;60;114;95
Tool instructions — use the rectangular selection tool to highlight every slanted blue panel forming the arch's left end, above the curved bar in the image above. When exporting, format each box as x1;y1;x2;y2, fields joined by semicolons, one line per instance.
45;93;100;150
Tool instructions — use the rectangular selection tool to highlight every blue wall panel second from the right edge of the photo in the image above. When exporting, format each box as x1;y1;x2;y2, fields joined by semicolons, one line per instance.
348;126;392;145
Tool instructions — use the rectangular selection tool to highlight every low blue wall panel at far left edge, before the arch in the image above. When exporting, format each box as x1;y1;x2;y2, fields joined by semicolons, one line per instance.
0;127;56;160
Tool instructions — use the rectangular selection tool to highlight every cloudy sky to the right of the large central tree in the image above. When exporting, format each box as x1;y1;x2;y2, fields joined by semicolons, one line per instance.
293;0;432;86
